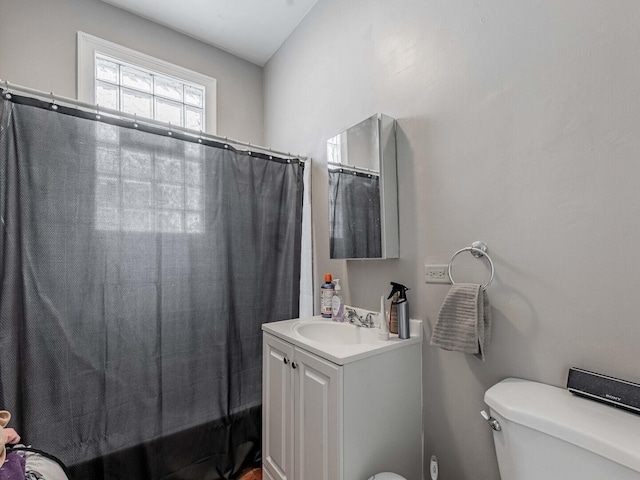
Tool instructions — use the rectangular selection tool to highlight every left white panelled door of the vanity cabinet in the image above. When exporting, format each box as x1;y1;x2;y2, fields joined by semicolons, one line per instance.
262;334;301;480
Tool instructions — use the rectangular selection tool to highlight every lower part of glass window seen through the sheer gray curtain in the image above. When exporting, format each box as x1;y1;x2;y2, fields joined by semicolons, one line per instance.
95;122;204;234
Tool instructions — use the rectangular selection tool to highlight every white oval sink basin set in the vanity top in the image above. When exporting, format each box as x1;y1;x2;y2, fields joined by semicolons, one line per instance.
293;322;378;345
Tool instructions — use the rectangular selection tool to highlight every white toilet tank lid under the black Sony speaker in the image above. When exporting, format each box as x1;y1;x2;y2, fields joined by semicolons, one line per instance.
484;378;640;472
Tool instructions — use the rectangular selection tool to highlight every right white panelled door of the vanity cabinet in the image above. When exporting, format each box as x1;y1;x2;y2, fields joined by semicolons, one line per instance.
292;348;342;480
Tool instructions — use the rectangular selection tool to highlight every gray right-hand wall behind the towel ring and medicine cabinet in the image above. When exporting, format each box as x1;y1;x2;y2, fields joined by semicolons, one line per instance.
264;0;640;480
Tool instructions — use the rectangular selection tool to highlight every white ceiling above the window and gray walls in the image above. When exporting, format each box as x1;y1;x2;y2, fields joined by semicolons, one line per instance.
102;0;317;66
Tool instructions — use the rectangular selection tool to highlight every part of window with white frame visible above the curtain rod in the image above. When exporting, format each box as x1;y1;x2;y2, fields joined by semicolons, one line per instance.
78;32;216;135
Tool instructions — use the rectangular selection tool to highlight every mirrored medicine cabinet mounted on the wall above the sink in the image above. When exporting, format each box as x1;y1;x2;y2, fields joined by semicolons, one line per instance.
327;113;400;260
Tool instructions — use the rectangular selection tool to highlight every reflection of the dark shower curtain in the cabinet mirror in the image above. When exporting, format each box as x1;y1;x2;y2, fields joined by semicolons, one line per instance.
329;169;382;258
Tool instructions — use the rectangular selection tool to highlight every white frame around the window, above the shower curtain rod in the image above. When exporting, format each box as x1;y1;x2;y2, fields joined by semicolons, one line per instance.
78;32;217;135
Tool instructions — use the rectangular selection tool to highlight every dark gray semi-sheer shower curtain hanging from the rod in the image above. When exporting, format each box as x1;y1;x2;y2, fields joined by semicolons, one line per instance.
0;92;303;480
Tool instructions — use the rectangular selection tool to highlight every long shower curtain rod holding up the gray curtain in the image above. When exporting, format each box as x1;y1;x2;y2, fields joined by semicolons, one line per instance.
0;79;308;163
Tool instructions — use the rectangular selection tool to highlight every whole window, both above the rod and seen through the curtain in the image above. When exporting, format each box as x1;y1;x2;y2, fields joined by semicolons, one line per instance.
78;32;208;234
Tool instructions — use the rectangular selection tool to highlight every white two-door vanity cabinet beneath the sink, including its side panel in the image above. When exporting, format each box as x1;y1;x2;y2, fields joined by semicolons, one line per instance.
262;320;422;480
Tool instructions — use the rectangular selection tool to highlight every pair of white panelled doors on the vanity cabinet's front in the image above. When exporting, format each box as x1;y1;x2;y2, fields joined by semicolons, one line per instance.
262;333;342;480
